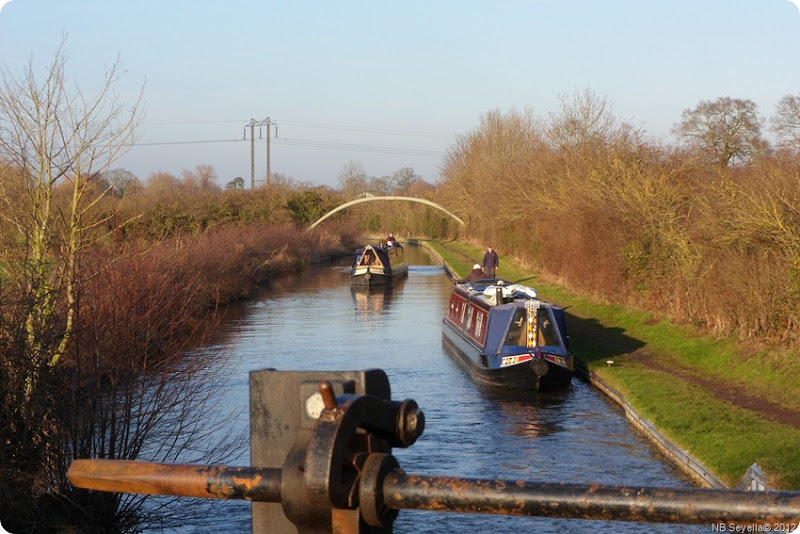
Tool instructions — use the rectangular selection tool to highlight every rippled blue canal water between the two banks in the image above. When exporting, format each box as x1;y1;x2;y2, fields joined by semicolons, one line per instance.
167;246;708;533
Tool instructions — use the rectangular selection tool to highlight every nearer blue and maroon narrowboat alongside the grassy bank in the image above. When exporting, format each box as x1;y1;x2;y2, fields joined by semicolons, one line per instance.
442;279;574;390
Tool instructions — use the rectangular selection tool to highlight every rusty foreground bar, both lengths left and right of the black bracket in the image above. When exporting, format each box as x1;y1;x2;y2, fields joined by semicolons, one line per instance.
69;455;800;524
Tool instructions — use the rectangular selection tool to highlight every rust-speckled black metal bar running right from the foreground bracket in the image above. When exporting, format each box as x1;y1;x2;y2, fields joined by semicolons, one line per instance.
383;470;800;525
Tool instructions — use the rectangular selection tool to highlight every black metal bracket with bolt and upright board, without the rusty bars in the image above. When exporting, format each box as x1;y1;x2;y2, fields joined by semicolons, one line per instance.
251;370;425;534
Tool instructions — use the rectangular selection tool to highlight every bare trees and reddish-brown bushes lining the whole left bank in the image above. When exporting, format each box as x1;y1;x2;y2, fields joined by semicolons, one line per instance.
0;46;366;532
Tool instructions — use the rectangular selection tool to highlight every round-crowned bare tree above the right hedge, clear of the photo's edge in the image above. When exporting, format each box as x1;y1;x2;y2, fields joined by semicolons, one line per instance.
673;96;766;166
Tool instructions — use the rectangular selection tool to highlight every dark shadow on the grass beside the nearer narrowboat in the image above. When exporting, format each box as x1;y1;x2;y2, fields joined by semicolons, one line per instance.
566;311;645;367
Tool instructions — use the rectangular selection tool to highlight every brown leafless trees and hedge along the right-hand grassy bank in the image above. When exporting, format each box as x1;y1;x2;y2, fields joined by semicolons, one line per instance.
438;91;800;343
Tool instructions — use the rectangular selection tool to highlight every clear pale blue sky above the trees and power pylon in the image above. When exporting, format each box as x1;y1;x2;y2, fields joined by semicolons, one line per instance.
0;0;800;185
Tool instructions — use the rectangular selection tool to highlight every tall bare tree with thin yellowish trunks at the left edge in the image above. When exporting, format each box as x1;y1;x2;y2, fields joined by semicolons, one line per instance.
0;42;141;378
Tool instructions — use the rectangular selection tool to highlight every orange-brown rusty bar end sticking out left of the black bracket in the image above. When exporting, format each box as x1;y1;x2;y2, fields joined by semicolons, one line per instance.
67;460;281;502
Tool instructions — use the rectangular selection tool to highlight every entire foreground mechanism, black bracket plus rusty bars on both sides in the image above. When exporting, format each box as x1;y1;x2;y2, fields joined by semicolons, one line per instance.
69;370;800;534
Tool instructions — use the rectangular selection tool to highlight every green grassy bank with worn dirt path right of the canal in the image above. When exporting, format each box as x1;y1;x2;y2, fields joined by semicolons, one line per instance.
428;241;800;490
